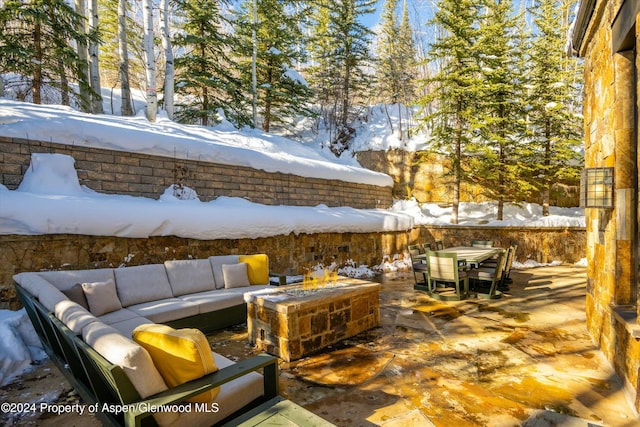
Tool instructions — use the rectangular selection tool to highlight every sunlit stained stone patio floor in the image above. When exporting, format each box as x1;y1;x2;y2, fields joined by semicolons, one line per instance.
0;265;640;427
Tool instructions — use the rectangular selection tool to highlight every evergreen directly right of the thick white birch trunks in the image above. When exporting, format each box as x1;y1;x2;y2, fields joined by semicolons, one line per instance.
173;0;251;127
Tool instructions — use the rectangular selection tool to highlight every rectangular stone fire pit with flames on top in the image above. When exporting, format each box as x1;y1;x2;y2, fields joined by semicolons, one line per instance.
245;277;380;362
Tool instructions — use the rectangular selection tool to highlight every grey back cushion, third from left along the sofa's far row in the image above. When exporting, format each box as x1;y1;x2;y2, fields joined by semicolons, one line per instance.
164;259;216;296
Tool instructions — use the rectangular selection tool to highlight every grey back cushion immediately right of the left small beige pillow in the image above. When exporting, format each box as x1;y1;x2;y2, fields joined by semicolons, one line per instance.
114;264;173;307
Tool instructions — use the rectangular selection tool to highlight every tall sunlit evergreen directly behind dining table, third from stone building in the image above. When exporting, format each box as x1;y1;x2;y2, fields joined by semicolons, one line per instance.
419;0;481;224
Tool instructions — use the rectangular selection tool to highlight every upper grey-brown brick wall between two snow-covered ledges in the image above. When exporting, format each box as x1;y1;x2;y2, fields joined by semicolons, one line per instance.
0;136;392;209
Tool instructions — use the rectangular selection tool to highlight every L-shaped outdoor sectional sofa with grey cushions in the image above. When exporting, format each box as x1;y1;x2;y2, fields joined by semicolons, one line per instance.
14;254;278;426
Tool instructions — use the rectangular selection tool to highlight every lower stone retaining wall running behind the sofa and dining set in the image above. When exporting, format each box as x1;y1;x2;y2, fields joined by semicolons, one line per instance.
0;226;586;309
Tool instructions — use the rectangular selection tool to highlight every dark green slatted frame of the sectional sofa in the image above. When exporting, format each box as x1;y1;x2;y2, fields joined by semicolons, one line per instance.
15;284;279;426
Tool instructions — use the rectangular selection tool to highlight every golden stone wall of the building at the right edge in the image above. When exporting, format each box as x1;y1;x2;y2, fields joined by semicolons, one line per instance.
574;0;640;410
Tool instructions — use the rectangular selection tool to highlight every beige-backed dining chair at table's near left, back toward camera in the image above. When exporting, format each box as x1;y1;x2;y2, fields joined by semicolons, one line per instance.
426;251;469;300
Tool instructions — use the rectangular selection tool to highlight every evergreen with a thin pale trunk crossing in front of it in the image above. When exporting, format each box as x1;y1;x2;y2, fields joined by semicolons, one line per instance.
235;0;314;132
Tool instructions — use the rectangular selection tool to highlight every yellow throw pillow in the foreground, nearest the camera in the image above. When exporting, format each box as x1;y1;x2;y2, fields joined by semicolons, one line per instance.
131;324;220;402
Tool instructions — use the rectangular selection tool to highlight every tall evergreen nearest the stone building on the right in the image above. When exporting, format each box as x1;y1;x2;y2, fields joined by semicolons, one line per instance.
528;0;582;215
